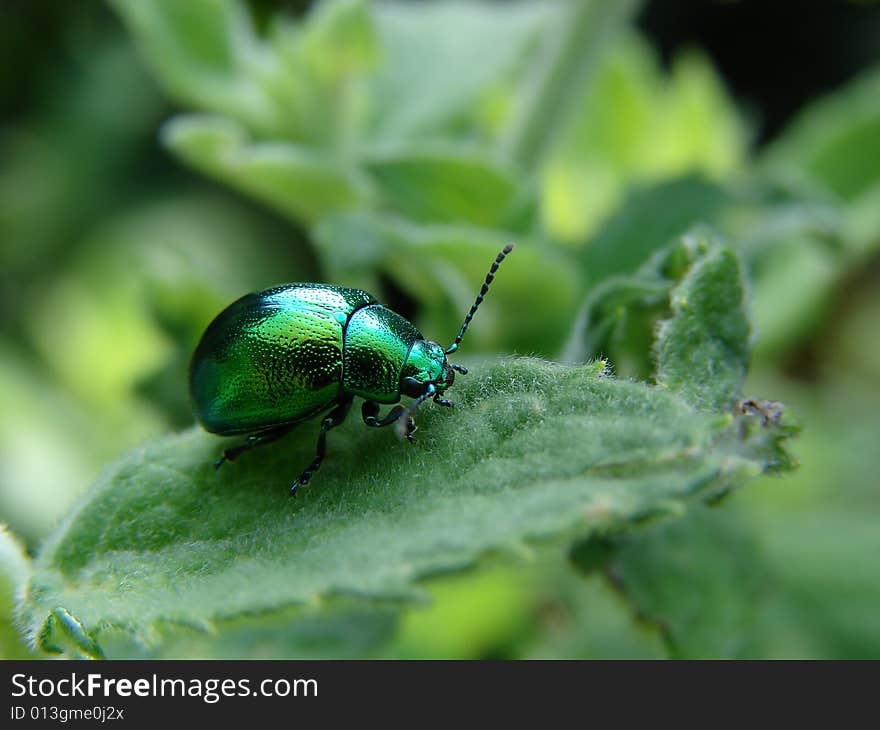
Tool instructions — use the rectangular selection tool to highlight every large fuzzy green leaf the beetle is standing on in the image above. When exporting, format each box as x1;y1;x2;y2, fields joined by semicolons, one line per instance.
21;359;792;655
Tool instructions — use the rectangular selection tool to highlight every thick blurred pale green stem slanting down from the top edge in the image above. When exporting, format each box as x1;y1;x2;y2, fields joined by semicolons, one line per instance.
502;0;640;169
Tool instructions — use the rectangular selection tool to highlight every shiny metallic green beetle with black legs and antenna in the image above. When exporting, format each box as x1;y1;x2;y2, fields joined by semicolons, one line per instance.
189;244;513;494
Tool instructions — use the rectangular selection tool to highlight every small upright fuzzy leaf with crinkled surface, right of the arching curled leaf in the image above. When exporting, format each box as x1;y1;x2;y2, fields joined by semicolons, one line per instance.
654;239;751;411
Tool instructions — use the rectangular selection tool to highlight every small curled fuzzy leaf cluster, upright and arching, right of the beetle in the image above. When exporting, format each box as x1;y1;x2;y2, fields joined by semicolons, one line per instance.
564;231;751;411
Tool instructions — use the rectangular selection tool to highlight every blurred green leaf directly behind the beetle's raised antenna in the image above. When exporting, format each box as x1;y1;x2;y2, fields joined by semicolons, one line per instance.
315;215;580;356
